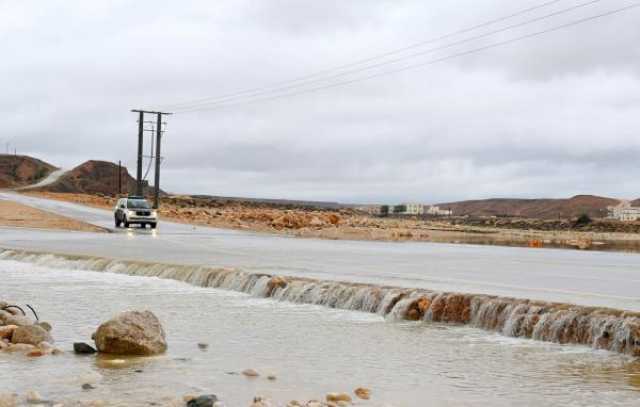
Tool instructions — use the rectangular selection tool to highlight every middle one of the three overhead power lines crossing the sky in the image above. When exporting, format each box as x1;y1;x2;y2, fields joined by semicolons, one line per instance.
169;0;602;111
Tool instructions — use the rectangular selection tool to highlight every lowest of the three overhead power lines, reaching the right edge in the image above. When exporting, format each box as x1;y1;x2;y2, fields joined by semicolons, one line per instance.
175;3;640;113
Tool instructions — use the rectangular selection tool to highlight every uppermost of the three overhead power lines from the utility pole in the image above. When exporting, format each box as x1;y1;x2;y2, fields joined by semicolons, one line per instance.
156;0;565;109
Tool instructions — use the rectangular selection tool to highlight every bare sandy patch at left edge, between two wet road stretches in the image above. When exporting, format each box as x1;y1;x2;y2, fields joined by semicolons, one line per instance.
0;200;104;232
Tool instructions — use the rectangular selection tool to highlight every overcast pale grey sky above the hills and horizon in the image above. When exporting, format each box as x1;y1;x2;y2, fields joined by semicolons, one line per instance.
0;0;640;203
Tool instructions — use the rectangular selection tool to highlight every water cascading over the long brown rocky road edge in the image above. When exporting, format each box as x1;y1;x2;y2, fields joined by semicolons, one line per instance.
0;245;640;357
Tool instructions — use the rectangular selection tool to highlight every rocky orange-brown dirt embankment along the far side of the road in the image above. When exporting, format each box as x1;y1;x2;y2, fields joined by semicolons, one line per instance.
18;192;640;251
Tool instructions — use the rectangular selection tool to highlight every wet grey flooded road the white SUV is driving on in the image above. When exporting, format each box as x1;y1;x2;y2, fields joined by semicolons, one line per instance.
0;193;640;311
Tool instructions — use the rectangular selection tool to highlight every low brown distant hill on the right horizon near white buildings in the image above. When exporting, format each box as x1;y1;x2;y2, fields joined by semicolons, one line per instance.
438;195;619;219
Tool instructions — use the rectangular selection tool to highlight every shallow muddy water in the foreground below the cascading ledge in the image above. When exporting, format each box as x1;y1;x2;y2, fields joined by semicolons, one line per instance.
0;261;640;406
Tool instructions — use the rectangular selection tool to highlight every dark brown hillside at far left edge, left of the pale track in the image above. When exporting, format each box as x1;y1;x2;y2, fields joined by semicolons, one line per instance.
0;154;56;188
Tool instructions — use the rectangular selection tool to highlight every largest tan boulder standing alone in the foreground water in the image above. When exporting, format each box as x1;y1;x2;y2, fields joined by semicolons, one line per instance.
94;311;167;356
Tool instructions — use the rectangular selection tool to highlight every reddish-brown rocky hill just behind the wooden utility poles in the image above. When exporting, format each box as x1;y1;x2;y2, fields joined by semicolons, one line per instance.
39;160;145;195
